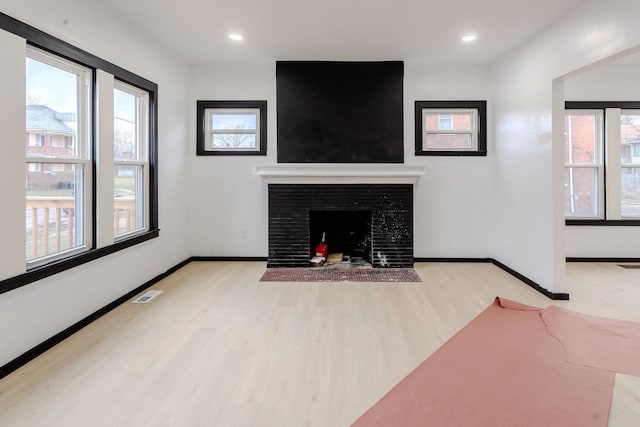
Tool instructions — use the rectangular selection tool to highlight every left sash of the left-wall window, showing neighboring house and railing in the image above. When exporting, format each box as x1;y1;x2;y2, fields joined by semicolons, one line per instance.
25;48;92;264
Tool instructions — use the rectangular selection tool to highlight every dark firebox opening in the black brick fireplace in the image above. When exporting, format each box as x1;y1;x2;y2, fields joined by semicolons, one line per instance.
309;210;372;266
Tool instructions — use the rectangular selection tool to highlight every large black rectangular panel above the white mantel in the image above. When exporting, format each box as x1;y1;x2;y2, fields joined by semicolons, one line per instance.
276;61;404;163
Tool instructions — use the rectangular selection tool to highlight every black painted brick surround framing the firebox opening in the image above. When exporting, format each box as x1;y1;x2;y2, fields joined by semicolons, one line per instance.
267;184;413;268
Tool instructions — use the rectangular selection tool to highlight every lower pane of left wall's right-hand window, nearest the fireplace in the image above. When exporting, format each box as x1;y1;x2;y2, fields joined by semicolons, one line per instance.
113;165;144;236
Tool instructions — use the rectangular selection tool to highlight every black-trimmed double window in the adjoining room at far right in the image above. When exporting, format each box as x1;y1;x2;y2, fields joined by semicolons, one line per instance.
565;102;640;225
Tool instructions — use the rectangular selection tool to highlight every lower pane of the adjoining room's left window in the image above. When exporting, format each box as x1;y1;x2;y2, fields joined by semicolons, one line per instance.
564;168;598;217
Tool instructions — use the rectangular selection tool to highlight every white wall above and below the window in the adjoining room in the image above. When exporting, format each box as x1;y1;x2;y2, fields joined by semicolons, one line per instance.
564;62;640;258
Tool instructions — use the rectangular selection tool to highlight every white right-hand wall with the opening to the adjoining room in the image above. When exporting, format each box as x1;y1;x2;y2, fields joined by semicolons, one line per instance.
492;0;640;292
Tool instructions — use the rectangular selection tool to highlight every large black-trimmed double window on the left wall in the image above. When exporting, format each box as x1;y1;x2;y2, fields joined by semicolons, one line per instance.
0;13;159;293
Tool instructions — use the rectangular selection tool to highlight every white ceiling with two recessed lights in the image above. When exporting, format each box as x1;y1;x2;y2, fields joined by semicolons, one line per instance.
103;0;582;64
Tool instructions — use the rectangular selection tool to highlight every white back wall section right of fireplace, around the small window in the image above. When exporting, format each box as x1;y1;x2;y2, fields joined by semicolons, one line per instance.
404;62;495;258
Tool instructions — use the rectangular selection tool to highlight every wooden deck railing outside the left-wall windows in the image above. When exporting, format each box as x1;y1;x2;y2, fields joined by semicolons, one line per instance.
26;197;136;259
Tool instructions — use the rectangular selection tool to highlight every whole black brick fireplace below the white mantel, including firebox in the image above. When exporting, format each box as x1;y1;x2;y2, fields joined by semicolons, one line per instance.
267;184;413;268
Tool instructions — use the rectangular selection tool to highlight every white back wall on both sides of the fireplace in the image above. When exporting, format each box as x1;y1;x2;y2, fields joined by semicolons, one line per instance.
189;61;492;258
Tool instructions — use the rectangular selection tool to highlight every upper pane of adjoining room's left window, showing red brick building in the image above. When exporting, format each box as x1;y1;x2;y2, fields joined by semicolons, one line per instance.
564;114;600;164
